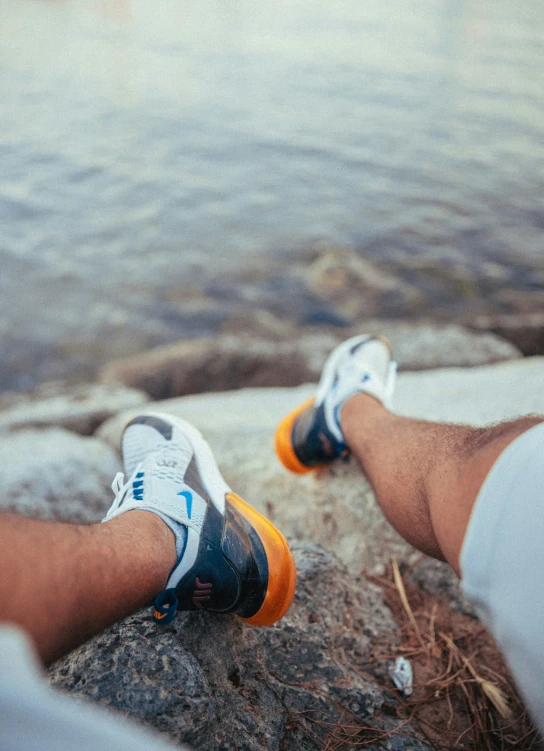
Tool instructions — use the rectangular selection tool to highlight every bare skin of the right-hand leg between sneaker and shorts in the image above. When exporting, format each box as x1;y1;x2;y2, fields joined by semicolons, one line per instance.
342;394;544;575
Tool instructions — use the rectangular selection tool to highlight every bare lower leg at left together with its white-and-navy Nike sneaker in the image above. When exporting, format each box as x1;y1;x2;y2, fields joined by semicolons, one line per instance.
0;413;296;662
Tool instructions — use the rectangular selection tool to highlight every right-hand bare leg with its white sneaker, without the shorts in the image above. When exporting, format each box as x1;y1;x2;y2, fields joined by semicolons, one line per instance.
276;334;544;574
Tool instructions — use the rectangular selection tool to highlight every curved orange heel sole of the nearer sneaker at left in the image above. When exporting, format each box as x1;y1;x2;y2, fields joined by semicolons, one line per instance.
227;493;297;626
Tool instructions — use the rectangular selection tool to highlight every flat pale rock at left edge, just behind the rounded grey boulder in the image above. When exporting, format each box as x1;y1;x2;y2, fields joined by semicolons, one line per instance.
0;383;149;435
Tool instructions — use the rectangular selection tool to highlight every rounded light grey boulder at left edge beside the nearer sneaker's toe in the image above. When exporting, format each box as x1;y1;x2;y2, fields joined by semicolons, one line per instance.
0;428;119;522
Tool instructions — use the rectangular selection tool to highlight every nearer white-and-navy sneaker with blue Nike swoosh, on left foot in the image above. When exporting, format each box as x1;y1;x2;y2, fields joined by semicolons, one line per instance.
103;412;296;626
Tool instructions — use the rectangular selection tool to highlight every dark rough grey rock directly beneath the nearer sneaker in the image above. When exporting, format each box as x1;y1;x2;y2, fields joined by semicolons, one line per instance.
50;545;428;751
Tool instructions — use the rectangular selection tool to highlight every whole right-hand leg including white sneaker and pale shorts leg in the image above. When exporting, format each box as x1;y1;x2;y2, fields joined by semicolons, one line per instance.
276;336;544;732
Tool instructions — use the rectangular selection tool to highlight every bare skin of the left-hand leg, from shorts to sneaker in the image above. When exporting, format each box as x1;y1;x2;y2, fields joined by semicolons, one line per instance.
0;511;176;663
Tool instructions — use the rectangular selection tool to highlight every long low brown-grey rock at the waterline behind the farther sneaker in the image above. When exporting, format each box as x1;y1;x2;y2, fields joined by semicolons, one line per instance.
100;321;520;399
